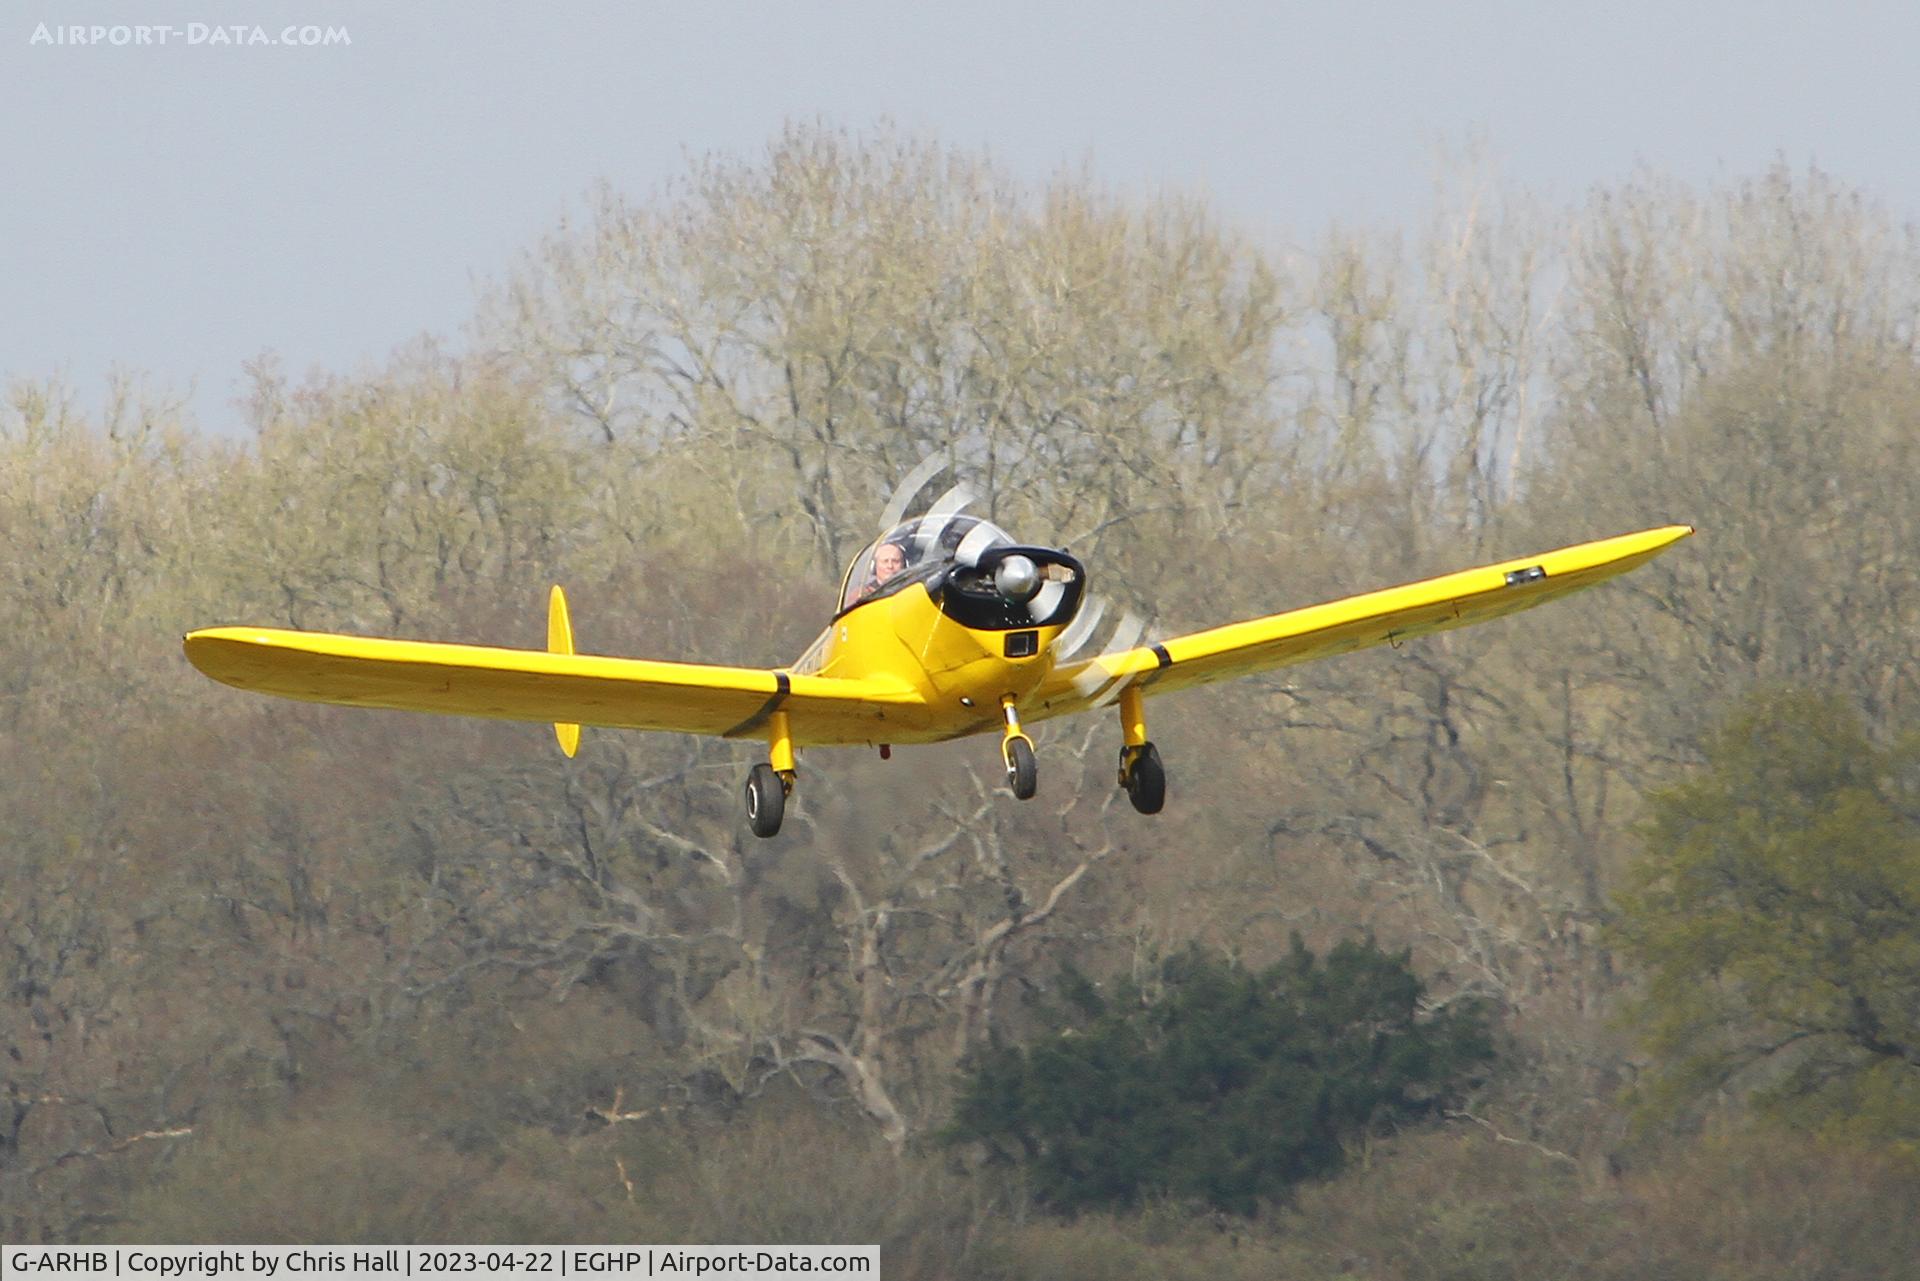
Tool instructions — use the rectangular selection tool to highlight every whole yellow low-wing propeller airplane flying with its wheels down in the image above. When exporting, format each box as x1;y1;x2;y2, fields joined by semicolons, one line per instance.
184;513;1693;837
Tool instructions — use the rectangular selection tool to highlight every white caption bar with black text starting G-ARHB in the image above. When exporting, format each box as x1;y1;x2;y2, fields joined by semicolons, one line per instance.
0;1245;879;1281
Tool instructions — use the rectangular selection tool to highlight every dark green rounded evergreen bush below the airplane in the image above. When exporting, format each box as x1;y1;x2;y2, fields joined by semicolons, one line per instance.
947;935;1492;1214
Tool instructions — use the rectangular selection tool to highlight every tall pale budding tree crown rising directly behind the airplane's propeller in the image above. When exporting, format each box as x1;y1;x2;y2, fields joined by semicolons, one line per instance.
488;127;1284;574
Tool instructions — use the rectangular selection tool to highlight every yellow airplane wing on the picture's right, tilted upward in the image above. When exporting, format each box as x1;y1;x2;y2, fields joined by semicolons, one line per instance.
1021;524;1693;720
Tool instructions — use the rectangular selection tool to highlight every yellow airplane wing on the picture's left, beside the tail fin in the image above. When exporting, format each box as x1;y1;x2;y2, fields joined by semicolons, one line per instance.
184;628;925;745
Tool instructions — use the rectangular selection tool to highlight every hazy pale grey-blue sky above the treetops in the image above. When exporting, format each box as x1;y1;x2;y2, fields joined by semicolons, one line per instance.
0;0;1920;430
